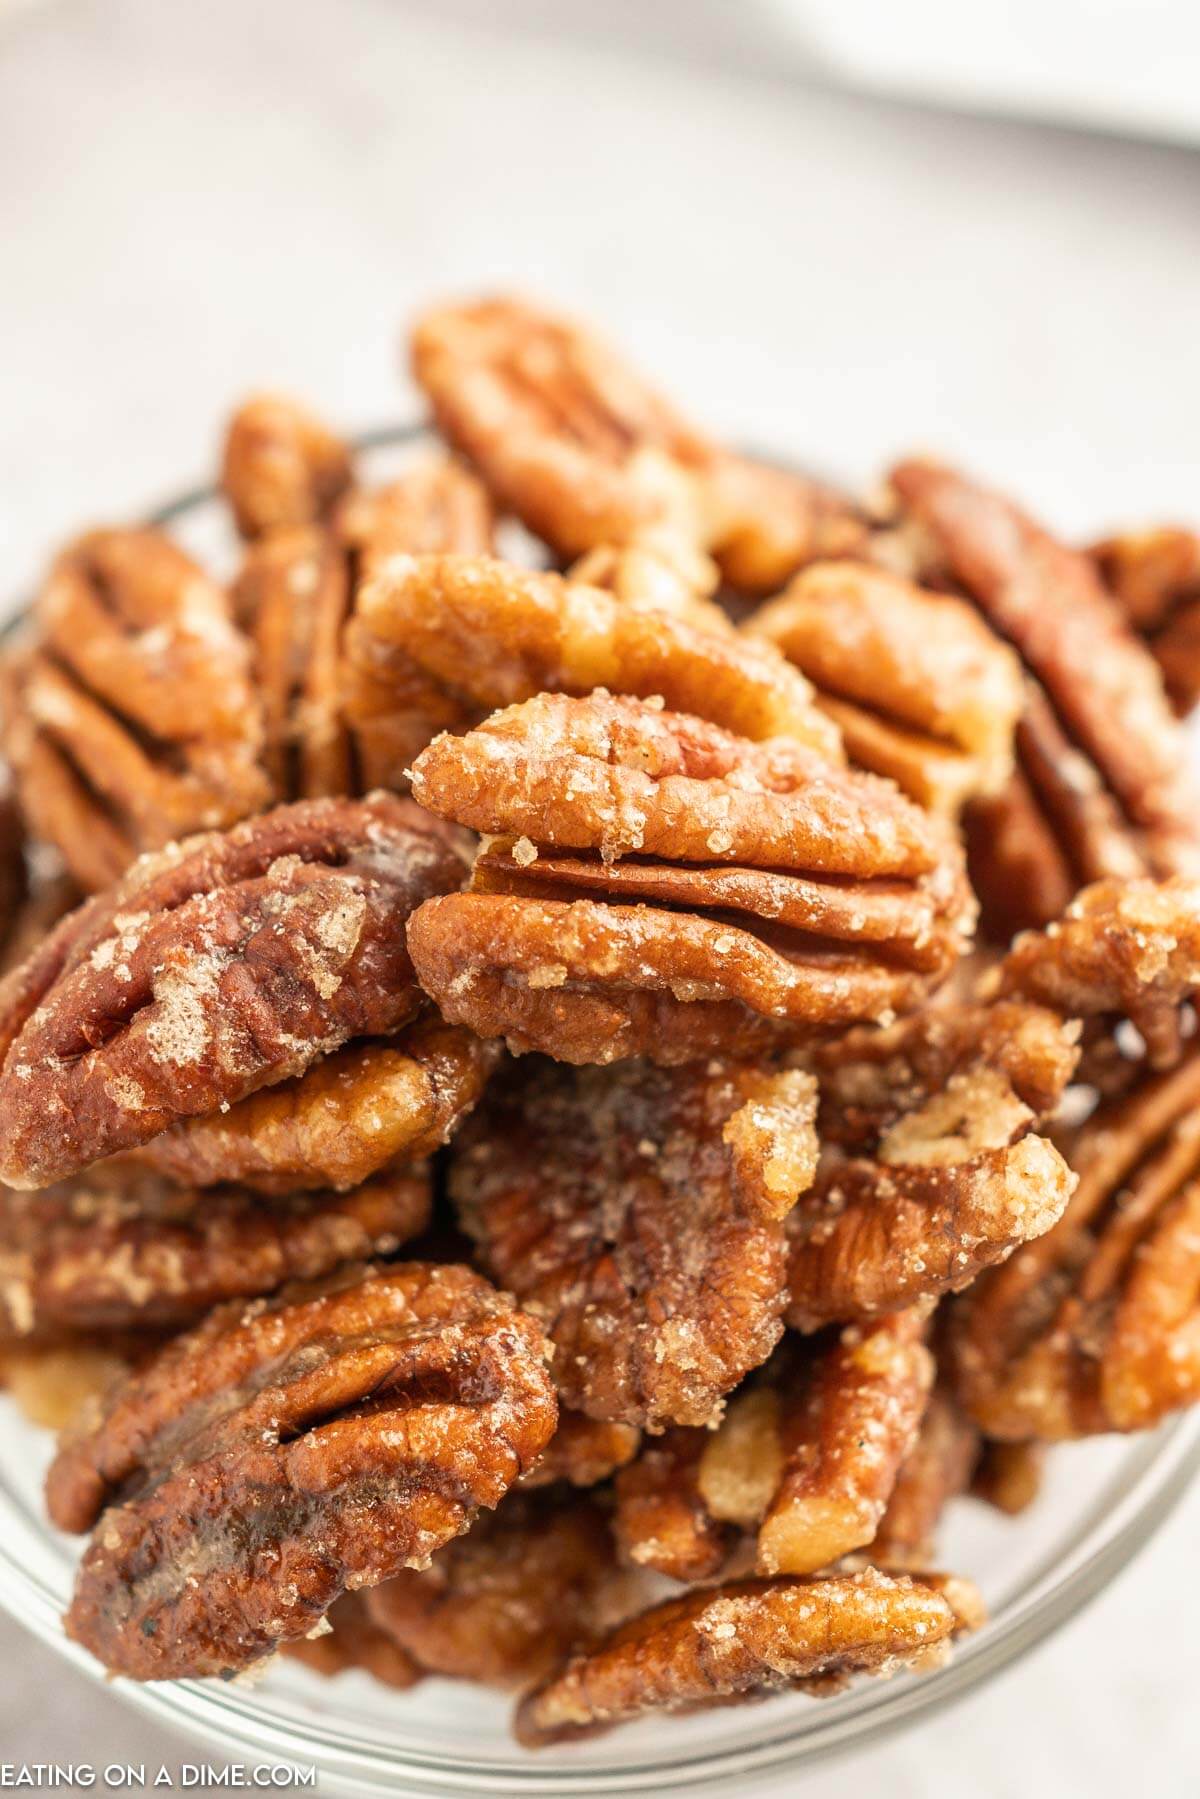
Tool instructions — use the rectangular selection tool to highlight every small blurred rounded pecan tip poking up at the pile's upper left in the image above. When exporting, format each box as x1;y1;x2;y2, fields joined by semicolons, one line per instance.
221;394;354;538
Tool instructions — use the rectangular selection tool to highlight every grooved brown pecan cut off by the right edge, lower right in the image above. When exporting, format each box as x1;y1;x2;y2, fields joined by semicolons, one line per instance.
950;1049;1200;1441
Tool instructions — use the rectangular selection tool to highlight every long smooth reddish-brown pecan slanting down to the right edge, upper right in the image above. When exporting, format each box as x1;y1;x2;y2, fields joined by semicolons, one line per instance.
891;461;1200;925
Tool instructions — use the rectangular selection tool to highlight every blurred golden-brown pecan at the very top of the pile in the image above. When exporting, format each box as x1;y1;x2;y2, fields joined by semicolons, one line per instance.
412;299;864;592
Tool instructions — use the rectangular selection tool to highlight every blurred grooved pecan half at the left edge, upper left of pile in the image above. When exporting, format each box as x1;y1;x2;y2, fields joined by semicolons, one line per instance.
4;531;268;889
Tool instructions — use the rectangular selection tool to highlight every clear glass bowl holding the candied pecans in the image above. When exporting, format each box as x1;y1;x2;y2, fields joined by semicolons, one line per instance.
0;428;1200;1799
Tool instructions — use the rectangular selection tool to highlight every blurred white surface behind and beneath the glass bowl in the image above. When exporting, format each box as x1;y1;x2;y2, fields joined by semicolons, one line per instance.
0;0;1200;1799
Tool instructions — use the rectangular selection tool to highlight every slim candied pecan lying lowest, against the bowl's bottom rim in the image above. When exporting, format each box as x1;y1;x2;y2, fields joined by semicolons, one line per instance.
516;1569;982;1747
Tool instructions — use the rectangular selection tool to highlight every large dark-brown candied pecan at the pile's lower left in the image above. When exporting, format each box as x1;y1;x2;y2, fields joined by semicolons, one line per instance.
47;1263;556;1680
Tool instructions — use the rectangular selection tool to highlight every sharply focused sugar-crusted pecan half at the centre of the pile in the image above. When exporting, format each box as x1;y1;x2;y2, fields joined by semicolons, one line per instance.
408;693;972;1061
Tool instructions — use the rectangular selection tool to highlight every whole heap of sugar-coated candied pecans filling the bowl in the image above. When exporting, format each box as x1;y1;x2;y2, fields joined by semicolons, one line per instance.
0;300;1200;1745
